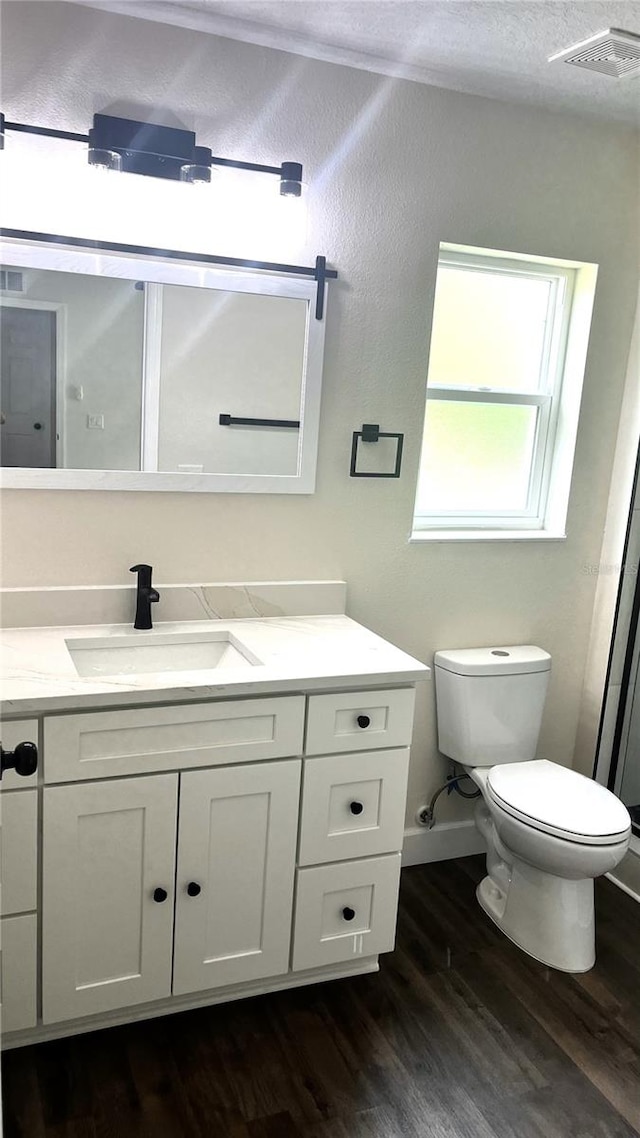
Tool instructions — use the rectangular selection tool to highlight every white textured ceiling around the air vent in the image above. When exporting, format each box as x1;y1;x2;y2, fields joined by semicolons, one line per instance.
81;0;640;124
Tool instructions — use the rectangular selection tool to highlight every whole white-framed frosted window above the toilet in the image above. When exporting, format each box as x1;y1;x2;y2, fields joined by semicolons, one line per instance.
412;247;596;539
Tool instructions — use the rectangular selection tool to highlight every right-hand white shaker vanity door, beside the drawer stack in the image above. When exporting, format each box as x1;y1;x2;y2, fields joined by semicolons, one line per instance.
173;759;301;996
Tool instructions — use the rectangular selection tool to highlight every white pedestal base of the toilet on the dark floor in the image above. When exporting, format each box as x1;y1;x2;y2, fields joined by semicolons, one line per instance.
476;858;596;972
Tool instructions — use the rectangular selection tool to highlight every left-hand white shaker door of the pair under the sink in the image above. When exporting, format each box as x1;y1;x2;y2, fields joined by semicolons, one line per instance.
42;774;178;1023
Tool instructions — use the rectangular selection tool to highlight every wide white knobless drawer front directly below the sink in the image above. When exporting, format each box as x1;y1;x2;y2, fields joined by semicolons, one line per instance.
44;695;304;782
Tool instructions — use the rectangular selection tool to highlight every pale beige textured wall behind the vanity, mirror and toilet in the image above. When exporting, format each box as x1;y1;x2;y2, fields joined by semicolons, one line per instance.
2;2;638;833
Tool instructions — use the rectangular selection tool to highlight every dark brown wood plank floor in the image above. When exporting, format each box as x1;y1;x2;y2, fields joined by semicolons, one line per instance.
2;858;640;1138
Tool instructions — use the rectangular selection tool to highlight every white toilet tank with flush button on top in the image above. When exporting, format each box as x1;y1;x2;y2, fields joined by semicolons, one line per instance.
434;644;551;767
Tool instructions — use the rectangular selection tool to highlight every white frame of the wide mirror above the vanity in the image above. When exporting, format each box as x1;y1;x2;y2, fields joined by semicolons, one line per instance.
0;234;325;494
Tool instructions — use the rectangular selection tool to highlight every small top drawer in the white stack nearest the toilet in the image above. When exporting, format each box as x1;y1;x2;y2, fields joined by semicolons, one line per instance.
305;687;416;754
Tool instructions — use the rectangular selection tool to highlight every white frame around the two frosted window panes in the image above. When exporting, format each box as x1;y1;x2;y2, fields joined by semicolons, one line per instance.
412;246;580;539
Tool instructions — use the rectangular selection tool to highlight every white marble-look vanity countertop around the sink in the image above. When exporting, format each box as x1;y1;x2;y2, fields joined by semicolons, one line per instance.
0;616;429;716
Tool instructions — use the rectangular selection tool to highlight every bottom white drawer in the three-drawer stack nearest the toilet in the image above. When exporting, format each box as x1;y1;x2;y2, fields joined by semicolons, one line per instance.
293;854;400;972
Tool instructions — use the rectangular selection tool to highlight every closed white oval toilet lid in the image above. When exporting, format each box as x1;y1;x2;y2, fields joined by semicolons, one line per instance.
486;759;631;846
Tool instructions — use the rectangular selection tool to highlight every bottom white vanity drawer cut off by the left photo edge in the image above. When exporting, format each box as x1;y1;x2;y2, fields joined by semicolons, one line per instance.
0;913;38;1032
